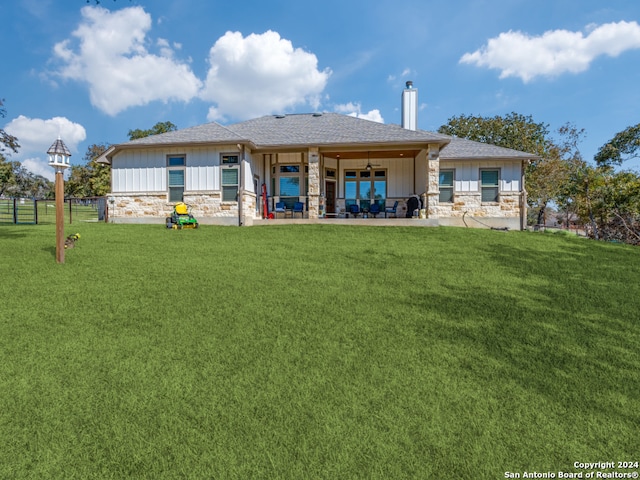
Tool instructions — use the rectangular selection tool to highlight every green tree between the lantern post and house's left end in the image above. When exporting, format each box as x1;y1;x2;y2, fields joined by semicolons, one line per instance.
65;144;111;198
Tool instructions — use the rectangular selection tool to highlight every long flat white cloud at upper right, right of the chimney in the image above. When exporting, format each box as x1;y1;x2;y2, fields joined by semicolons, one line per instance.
460;21;640;83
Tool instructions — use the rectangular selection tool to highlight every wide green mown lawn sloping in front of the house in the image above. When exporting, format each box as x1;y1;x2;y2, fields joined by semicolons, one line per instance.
0;224;640;479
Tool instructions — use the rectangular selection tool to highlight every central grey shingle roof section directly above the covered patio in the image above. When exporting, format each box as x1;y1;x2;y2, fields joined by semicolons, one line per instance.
228;113;449;147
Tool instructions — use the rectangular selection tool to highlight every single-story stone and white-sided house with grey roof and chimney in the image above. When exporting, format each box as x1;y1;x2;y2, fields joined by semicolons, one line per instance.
99;82;536;229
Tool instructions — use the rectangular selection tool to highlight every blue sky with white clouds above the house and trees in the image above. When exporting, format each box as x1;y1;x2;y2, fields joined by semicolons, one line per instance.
0;0;640;178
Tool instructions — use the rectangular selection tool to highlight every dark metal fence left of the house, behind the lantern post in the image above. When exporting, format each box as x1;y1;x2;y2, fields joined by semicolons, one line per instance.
0;197;109;225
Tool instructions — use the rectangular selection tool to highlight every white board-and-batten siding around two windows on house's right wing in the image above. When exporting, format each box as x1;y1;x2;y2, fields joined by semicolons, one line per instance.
440;160;522;193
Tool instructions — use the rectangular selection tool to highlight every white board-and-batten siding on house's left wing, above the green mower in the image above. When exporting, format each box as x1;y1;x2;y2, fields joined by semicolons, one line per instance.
111;145;251;193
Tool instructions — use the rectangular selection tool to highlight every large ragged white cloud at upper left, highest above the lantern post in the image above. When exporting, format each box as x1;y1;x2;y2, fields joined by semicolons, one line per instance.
54;6;202;115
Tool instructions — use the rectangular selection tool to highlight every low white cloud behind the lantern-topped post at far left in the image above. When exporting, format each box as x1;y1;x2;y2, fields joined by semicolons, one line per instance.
4;115;87;180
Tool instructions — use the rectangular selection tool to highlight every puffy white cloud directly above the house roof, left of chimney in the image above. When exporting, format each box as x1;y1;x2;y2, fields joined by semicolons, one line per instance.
201;31;331;120
